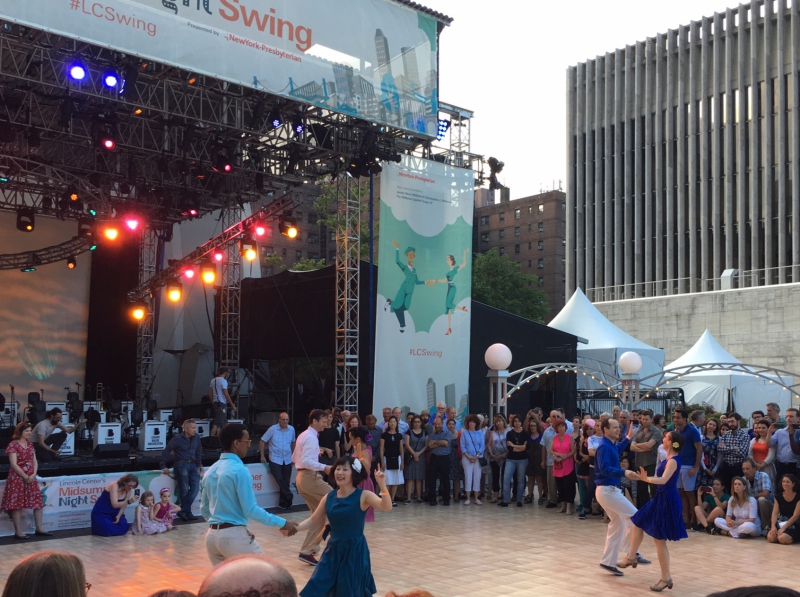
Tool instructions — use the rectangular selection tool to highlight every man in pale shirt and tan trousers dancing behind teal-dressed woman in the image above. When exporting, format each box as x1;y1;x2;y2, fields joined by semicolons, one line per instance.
292;409;331;566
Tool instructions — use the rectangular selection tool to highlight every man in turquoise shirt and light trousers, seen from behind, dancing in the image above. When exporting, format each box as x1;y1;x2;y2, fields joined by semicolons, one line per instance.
200;423;297;566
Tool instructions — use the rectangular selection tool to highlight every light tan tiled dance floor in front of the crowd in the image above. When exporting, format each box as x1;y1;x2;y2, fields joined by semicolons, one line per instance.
0;502;800;597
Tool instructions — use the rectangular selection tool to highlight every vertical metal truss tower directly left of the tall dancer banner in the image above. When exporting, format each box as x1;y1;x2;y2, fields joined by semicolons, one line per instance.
336;176;363;412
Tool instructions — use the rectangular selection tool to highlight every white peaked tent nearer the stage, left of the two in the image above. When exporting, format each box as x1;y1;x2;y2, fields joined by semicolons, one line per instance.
549;288;664;389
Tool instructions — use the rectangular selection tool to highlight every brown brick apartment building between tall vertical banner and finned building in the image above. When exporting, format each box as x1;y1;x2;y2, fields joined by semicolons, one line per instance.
473;189;567;322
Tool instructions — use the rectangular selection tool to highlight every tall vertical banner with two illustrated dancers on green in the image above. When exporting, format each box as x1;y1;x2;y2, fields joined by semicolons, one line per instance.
373;156;474;420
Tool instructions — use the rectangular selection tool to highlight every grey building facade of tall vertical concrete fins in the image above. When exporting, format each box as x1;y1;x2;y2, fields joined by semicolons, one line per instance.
566;0;800;302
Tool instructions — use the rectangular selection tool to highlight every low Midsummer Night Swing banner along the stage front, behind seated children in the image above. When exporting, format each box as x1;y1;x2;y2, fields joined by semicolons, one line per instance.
0;463;305;537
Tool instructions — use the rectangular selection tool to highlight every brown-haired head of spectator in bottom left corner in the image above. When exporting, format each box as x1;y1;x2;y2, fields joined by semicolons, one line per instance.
2;551;86;597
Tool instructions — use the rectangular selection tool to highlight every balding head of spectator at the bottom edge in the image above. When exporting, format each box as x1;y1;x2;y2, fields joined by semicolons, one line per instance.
197;554;297;597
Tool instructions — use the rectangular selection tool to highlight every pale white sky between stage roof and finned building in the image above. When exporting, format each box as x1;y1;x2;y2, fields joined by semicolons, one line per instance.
428;0;748;199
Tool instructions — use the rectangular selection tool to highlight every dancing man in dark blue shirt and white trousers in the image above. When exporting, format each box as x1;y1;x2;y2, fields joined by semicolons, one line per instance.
594;419;650;576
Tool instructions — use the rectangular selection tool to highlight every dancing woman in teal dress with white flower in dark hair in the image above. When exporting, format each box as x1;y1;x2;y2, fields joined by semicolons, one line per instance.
297;456;392;597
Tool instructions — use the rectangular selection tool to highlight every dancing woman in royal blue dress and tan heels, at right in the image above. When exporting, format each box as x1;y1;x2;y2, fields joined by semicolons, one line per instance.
617;431;688;593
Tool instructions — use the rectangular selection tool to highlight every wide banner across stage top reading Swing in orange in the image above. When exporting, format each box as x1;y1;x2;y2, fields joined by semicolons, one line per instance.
0;0;439;137
